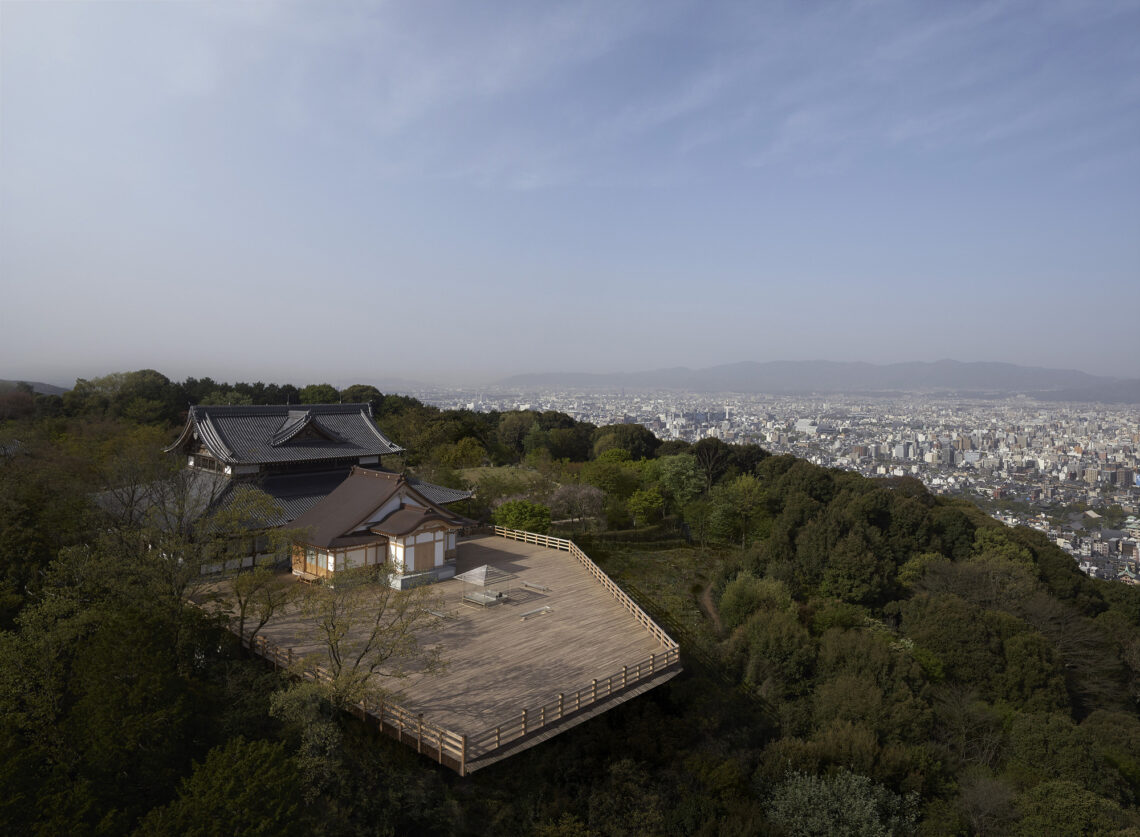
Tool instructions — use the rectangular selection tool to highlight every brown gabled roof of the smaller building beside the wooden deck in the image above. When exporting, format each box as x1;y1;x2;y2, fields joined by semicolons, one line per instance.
293;466;465;547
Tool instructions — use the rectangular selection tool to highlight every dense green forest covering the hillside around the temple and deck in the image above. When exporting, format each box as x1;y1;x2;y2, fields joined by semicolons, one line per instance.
0;371;1140;836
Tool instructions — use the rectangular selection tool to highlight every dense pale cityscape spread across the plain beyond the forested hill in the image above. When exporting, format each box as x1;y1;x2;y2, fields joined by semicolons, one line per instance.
415;389;1140;584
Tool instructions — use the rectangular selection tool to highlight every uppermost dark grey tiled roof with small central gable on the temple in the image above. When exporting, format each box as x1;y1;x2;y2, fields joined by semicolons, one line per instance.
166;404;404;465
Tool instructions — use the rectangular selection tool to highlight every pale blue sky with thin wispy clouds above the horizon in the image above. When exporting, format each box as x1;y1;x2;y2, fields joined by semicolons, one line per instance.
0;0;1140;385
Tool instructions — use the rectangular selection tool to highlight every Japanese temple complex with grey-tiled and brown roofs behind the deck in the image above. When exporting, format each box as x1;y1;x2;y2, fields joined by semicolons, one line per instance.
166;404;471;586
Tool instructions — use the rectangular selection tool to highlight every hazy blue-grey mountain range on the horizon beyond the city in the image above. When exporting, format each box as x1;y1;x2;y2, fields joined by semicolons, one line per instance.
499;360;1140;404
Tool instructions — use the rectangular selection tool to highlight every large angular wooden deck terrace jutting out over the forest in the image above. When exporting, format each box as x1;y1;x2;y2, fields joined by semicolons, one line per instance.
249;535;678;771
